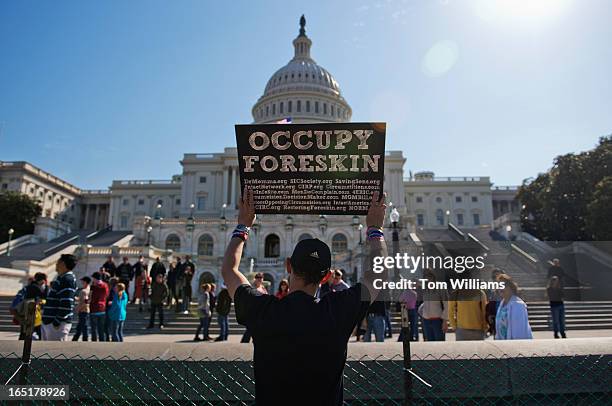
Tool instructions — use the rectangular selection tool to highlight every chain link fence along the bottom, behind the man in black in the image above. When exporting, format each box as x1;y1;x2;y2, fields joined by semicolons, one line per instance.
0;353;612;405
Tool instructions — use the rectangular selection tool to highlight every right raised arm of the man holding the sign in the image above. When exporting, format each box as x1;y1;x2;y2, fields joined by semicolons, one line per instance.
362;192;387;302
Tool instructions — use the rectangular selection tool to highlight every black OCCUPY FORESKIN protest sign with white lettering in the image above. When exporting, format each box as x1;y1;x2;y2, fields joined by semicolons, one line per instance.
236;123;386;215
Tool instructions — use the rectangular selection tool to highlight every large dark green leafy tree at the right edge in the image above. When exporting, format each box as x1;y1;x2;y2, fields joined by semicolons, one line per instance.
517;135;612;241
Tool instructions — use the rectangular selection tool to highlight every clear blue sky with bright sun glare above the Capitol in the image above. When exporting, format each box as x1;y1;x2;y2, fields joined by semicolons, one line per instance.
0;0;612;188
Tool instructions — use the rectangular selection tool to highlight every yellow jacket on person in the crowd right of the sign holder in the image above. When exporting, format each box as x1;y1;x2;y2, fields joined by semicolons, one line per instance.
448;289;489;341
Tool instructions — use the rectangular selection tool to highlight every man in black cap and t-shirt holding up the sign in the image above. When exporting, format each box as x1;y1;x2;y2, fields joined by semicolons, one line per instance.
221;187;387;406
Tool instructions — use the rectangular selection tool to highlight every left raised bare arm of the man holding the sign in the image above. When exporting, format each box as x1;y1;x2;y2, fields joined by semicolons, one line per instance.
221;187;255;298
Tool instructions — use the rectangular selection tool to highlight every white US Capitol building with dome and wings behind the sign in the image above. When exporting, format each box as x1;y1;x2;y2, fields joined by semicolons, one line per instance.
0;17;519;285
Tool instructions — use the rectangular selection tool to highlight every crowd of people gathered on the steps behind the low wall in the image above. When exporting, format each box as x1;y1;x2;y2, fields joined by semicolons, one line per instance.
5;255;566;343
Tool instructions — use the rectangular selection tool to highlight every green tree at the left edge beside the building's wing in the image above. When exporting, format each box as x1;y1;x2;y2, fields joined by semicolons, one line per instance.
0;192;42;243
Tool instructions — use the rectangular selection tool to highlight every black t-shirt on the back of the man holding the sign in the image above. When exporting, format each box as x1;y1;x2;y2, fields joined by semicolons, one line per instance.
234;284;369;405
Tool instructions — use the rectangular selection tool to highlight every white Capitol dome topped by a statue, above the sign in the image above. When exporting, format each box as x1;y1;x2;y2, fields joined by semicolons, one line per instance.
252;16;352;123
